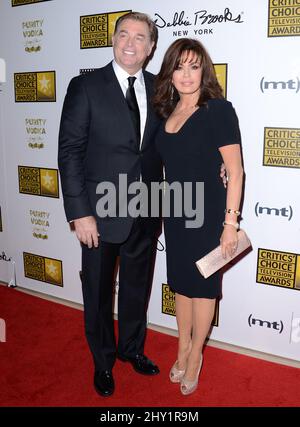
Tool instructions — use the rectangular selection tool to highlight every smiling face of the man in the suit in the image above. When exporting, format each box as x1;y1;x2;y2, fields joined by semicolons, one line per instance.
112;19;154;75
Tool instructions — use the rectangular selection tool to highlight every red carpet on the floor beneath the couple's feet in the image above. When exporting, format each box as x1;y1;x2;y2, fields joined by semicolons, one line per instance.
0;286;300;407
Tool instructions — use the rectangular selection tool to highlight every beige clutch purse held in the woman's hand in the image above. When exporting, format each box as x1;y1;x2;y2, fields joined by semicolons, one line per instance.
196;230;251;279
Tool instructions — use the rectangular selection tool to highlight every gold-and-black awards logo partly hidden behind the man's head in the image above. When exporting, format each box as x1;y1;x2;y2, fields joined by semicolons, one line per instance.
80;10;131;49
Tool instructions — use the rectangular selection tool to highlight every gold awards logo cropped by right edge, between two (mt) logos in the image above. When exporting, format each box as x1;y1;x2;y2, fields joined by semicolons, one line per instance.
263;127;300;169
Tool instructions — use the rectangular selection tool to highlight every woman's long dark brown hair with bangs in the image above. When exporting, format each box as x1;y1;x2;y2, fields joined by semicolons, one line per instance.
153;38;223;118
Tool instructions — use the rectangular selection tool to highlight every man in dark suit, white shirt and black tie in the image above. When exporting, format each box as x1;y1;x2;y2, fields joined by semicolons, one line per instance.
58;12;162;396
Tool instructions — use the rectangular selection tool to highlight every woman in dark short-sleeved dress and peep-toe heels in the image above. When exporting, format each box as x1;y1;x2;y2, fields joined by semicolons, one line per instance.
154;39;243;394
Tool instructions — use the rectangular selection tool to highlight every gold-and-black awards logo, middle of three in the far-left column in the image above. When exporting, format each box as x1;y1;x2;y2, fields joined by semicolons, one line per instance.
18;166;59;198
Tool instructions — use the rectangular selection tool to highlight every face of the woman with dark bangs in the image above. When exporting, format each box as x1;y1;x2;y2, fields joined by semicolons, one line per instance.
172;52;202;95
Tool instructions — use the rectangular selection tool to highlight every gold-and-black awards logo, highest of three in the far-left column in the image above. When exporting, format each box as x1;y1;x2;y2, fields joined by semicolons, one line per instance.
14;71;56;102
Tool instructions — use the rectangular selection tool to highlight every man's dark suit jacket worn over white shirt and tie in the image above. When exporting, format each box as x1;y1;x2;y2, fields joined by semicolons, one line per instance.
58;63;162;243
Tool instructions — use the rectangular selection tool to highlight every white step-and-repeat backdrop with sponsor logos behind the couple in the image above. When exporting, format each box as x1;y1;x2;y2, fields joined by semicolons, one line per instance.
0;0;300;360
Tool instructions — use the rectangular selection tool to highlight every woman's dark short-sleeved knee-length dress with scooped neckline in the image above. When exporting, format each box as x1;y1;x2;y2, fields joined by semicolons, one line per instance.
156;99;240;298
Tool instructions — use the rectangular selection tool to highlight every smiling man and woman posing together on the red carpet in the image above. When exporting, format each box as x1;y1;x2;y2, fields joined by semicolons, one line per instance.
58;12;243;396
